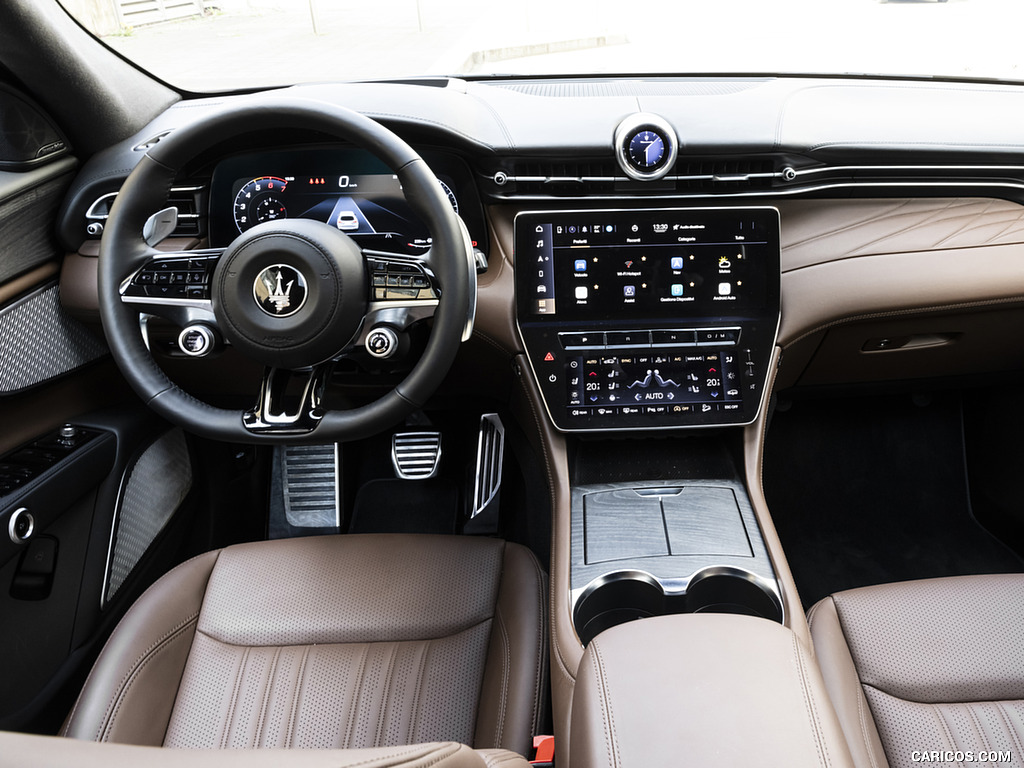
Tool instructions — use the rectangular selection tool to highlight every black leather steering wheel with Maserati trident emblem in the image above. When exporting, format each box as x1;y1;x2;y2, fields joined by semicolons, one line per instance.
98;97;476;443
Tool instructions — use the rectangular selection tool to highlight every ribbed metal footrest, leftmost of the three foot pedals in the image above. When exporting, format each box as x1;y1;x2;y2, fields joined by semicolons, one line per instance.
282;442;341;528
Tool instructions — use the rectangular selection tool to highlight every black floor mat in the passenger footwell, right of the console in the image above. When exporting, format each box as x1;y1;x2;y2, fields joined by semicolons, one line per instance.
764;395;1024;608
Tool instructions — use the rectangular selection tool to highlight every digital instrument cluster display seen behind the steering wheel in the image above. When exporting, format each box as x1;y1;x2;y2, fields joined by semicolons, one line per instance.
210;146;485;258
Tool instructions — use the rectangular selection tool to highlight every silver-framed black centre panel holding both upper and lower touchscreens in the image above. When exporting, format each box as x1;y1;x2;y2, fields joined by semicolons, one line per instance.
515;208;779;431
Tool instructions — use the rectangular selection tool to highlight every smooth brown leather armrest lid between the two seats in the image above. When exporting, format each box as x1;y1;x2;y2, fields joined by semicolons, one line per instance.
569;613;853;768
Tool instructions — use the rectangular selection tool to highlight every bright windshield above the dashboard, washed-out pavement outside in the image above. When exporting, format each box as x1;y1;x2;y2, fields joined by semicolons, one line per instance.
62;0;1024;92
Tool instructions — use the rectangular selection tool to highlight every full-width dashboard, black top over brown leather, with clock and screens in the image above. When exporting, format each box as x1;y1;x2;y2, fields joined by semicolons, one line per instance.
59;78;1024;417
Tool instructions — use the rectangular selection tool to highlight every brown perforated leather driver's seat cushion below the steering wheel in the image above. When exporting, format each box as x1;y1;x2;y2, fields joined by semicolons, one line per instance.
63;535;547;754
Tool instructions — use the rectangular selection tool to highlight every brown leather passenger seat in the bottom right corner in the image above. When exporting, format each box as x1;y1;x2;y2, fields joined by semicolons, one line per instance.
808;574;1024;768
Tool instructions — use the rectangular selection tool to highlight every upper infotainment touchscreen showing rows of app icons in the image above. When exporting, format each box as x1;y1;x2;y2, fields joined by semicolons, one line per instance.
516;209;778;319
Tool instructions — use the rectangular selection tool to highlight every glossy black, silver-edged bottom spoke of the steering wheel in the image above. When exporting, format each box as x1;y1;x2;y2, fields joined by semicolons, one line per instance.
242;362;334;435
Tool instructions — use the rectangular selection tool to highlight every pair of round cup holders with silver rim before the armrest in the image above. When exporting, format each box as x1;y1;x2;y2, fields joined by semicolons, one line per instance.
572;567;782;646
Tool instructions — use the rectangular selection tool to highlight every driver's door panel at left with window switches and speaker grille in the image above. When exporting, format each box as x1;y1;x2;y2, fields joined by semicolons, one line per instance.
0;86;193;732
